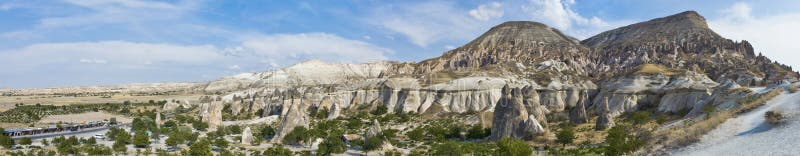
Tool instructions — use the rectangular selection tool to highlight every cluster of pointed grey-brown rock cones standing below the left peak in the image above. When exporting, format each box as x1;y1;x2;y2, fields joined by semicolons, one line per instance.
489;85;545;140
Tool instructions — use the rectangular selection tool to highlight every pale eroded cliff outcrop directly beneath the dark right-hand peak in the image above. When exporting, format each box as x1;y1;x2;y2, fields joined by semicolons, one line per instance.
592;64;718;117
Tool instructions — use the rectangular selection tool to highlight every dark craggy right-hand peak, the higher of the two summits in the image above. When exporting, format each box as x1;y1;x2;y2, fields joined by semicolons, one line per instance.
581;11;798;86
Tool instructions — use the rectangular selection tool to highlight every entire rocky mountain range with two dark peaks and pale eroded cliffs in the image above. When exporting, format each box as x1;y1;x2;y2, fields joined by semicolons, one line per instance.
178;11;798;142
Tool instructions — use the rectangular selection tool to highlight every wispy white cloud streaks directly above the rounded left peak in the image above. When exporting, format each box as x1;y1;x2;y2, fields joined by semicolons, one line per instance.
366;0;630;47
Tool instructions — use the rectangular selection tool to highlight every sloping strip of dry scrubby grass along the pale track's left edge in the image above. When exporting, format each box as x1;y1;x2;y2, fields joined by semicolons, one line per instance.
649;89;783;150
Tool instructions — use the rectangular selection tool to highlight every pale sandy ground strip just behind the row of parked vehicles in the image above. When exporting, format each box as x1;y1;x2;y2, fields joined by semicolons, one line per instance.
39;112;132;123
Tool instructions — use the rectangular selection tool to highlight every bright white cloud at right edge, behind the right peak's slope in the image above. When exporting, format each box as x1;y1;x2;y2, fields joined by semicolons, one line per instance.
709;2;800;69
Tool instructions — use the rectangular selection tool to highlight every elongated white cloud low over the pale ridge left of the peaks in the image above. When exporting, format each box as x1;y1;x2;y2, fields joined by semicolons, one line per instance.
236;33;392;65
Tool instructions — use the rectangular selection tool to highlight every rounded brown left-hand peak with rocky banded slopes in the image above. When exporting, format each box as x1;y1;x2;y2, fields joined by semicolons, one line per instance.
415;21;589;74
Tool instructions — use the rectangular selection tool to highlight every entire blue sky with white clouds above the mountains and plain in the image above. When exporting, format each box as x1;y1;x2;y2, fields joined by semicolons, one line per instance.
0;0;800;88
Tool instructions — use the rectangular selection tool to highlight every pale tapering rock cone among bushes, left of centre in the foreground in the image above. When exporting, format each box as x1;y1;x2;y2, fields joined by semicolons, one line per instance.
272;103;310;143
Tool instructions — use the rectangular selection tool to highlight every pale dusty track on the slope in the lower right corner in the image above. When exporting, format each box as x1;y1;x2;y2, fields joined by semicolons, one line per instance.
670;86;800;155
